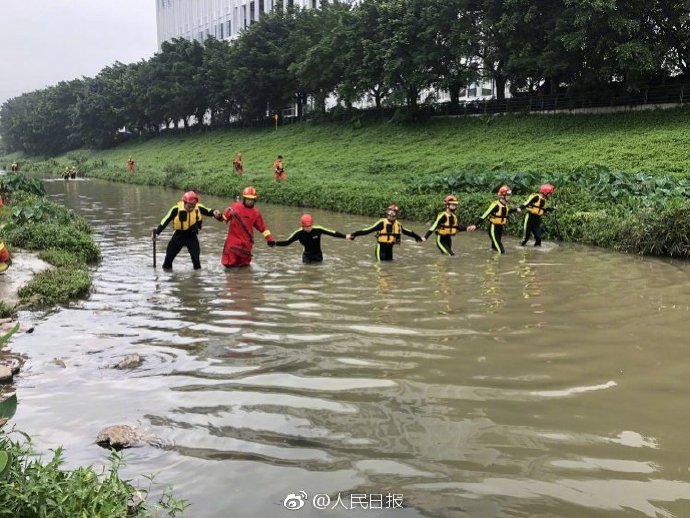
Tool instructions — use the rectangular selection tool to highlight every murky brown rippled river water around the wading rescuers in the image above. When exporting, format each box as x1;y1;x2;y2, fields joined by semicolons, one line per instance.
12;181;690;517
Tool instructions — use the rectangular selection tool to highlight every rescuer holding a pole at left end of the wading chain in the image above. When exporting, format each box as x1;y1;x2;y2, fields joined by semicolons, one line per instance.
153;191;220;270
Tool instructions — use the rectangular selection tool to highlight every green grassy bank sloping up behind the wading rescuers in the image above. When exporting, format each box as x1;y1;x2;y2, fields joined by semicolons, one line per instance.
4;108;690;257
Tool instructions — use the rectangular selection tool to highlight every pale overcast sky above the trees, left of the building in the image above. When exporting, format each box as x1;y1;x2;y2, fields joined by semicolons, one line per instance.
0;0;158;105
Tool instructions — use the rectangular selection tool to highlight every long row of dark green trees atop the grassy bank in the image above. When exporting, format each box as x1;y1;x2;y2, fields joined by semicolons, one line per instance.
0;0;690;155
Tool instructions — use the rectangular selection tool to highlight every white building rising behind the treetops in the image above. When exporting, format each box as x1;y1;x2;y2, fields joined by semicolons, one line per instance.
156;0;320;49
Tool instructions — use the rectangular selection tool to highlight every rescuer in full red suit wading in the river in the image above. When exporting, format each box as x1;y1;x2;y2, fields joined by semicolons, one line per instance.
220;185;274;268
